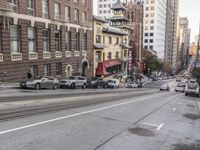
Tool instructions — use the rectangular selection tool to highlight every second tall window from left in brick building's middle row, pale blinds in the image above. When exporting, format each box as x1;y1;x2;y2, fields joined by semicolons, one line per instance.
28;28;36;52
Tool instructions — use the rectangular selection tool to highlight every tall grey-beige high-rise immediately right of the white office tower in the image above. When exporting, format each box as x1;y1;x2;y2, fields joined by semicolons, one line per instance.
165;0;179;72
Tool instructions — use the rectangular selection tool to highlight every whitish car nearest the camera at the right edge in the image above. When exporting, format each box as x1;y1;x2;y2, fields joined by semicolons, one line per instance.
185;83;200;97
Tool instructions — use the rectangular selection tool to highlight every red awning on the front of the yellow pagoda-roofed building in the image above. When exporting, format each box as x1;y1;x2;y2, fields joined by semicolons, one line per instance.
96;59;122;76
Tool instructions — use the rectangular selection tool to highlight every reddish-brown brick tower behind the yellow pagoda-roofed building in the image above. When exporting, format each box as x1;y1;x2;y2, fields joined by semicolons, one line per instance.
124;1;144;71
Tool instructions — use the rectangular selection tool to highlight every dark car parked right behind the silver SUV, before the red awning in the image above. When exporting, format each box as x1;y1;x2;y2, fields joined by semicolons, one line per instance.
86;77;108;88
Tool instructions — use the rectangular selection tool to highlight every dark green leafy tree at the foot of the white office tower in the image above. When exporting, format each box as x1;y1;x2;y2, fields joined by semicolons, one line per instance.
144;56;163;72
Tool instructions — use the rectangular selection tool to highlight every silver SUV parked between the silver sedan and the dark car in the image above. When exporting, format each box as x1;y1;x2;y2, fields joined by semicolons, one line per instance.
60;76;87;89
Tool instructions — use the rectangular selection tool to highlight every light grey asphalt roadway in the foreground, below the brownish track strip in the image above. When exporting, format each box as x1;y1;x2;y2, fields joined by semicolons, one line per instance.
0;81;200;150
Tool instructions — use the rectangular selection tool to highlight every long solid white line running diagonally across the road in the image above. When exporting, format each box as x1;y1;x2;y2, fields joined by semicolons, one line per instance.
0;95;155;135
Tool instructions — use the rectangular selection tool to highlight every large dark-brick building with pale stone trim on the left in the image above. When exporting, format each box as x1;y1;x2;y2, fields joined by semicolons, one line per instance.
0;0;93;81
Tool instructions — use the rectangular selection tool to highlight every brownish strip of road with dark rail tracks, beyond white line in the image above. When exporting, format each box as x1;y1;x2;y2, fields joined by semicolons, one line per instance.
0;90;159;121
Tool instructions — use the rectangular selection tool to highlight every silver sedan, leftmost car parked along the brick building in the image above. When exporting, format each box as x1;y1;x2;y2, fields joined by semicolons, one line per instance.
20;76;59;90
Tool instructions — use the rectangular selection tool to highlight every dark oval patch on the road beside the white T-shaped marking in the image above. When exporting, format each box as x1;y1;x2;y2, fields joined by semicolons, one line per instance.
129;127;156;136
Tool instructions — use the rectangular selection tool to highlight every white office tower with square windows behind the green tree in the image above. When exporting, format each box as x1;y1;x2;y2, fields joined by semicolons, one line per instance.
143;0;167;59
